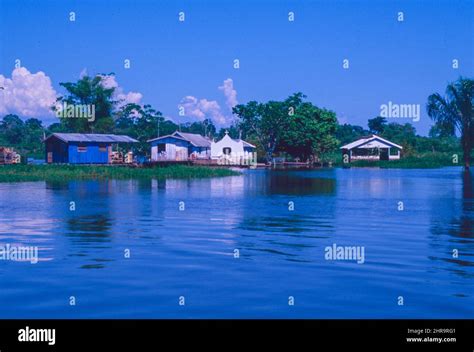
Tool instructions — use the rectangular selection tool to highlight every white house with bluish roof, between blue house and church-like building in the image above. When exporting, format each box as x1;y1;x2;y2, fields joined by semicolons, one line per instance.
148;131;211;161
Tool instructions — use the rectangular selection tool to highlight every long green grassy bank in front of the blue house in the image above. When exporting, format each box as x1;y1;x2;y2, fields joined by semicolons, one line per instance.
0;165;239;182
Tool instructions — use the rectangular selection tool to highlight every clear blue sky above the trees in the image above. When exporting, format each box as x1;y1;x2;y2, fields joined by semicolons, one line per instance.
0;0;474;134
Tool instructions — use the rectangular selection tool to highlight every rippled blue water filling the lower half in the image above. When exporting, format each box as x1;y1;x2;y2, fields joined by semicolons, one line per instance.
0;168;474;319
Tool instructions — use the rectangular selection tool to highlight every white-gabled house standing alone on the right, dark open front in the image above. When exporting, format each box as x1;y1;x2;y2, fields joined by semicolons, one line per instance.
340;134;403;162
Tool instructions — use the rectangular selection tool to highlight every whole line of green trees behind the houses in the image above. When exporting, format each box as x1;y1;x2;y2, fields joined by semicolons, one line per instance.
0;75;474;167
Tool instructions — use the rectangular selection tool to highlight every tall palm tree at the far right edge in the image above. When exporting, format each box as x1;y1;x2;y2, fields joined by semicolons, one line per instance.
426;77;474;170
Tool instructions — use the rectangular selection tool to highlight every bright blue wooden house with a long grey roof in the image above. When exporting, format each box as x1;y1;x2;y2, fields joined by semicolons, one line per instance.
44;133;138;164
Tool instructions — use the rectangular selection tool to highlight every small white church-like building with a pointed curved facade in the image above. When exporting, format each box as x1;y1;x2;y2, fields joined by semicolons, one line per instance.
211;131;256;164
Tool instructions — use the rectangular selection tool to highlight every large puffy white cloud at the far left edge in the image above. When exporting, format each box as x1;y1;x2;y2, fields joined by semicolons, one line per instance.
0;67;57;117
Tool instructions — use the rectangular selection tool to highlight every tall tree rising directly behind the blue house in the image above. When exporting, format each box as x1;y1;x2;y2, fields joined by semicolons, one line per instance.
52;75;118;133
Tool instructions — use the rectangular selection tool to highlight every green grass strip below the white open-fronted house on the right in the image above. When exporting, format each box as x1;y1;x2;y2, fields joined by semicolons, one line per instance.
338;153;463;169
